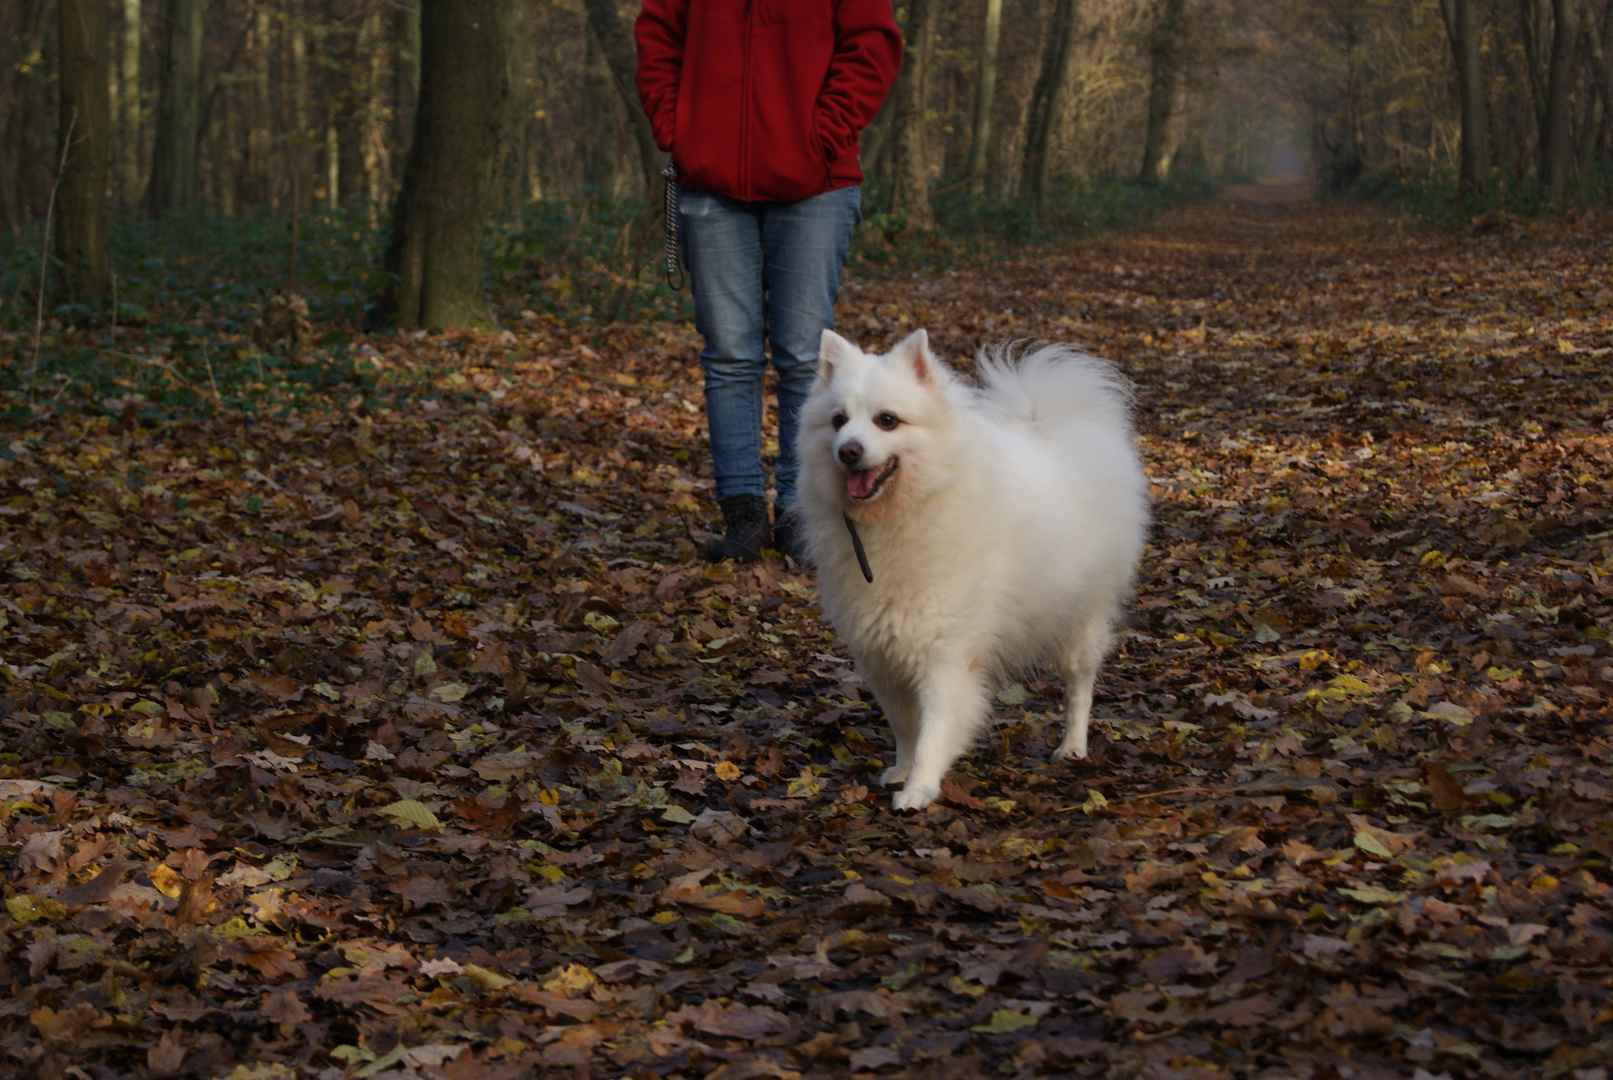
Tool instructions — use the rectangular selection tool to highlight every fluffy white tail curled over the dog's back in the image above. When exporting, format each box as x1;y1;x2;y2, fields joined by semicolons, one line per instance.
976;345;1132;432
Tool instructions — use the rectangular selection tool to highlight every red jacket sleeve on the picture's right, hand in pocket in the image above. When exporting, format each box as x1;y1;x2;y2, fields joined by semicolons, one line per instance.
812;0;902;161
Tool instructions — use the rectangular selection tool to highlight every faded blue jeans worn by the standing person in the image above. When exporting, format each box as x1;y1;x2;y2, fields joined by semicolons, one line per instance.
677;187;863;508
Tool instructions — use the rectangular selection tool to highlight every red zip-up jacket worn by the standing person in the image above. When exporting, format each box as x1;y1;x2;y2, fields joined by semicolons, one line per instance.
632;0;902;203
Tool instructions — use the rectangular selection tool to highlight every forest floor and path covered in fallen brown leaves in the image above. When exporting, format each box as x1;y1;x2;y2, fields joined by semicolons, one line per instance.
0;199;1613;1080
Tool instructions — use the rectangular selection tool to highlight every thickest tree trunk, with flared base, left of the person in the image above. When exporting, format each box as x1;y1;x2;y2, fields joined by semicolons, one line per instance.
371;0;510;327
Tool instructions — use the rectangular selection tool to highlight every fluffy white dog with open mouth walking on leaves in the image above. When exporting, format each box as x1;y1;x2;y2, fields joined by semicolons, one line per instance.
797;330;1148;809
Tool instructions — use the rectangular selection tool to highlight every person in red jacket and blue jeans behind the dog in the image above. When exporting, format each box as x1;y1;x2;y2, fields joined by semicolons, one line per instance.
634;0;902;563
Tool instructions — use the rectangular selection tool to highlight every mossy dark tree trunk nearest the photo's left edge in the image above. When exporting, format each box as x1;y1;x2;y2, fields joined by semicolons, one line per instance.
56;0;111;303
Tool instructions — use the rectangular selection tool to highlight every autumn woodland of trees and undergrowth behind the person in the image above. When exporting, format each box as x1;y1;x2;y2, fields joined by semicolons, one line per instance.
0;0;1613;354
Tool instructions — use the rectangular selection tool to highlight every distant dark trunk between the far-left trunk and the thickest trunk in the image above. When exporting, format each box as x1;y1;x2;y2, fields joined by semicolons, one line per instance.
148;0;203;218
